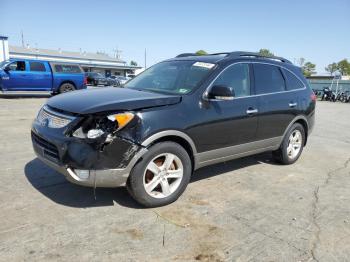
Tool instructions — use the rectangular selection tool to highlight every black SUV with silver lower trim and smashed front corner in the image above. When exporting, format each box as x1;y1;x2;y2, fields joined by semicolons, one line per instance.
32;52;316;207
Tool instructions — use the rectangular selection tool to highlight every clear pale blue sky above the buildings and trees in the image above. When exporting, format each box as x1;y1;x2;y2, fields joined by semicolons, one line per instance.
0;0;350;73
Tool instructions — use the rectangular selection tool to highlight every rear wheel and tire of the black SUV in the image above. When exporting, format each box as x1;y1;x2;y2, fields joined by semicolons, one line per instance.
272;123;305;165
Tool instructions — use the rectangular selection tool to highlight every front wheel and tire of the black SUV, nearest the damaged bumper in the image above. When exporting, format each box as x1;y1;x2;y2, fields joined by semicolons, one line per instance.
127;142;192;207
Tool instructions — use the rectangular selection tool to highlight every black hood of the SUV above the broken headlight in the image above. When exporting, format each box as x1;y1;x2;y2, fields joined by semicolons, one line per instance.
47;87;181;114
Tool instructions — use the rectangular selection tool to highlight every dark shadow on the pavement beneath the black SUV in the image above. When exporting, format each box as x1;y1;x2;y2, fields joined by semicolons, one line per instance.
24;153;275;209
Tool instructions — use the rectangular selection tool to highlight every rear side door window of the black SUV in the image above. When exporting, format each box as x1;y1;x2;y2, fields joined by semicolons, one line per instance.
253;64;286;94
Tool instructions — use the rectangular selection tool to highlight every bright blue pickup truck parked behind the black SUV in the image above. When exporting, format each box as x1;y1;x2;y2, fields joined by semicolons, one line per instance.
0;59;87;94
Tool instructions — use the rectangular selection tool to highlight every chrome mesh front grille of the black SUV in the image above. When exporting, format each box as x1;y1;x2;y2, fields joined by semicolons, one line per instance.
37;106;73;128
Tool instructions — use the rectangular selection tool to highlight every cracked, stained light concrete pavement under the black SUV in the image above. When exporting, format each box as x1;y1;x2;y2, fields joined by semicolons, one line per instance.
0;98;350;261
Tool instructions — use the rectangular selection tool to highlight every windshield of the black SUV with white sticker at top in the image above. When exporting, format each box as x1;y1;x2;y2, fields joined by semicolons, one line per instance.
124;61;215;94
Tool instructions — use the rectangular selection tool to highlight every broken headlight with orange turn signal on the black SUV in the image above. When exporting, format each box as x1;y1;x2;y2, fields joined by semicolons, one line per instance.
73;112;134;140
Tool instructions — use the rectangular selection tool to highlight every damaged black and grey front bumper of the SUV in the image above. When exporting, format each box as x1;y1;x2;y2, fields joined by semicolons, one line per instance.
31;117;147;187
